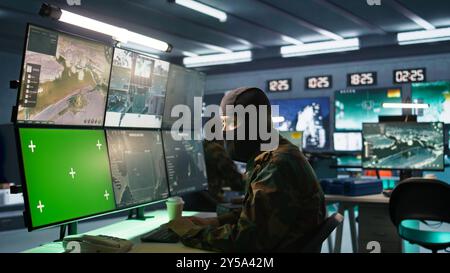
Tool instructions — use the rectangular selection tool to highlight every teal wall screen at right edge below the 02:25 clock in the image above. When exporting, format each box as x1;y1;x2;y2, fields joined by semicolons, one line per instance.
411;81;450;124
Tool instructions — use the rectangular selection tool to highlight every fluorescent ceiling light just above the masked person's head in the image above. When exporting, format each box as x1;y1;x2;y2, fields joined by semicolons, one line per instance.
183;51;252;67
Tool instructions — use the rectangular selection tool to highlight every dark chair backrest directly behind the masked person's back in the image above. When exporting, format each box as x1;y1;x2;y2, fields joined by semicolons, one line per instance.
301;213;344;253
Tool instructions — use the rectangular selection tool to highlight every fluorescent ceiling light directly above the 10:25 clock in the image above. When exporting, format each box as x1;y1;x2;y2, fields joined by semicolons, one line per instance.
280;38;360;58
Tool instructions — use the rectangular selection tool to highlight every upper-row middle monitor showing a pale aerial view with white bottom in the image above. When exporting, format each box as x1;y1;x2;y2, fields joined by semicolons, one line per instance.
105;48;170;128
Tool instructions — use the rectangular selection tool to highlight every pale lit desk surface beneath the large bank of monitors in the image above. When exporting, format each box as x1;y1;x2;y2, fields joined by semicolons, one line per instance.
25;210;216;253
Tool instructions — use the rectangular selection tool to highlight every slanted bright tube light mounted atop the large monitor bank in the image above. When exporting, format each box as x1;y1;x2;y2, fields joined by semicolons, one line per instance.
39;4;172;52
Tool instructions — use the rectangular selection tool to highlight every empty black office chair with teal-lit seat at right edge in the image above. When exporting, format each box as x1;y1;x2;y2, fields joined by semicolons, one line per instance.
389;178;450;253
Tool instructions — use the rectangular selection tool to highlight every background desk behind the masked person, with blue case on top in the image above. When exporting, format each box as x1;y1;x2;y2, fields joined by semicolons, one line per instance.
325;194;402;253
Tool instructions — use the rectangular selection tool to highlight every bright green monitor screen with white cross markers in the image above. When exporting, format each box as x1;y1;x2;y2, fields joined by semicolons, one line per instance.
18;128;116;231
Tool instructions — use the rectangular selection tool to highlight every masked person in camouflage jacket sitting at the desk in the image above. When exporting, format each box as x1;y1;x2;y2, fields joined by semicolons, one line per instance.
169;88;325;252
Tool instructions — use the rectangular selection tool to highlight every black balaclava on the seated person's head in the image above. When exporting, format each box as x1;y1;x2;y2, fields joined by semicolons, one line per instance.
220;87;272;162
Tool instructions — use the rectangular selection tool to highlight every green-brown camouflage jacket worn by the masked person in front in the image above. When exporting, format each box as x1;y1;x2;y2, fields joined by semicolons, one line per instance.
182;137;325;252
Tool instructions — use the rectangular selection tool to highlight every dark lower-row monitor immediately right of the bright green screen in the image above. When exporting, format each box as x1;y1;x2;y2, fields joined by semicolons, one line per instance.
106;130;169;208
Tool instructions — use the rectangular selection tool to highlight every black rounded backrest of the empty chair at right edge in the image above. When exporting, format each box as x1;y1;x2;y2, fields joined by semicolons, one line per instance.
389;178;450;227
